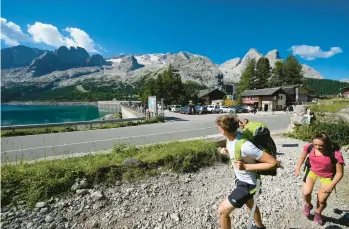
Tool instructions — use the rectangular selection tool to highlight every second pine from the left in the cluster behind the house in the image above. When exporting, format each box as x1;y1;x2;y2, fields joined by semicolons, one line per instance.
254;57;271;89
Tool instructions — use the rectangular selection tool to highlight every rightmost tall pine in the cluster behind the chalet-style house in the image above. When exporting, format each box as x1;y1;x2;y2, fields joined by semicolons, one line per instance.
285;55;304;85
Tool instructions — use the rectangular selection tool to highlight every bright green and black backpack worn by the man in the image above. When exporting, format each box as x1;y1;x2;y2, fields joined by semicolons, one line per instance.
235;121;276;176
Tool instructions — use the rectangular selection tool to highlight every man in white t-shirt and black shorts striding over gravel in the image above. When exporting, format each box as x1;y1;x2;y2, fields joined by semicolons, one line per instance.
216;115;278;229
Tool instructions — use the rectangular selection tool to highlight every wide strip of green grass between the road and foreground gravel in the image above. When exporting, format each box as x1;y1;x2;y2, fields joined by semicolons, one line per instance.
1;140;222;206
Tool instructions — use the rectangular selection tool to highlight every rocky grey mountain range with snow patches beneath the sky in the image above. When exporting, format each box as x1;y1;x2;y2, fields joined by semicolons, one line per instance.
1;45;324;90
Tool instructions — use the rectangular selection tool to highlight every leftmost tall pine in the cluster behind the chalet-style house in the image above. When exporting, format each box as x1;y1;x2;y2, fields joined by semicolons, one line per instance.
237;59;256;104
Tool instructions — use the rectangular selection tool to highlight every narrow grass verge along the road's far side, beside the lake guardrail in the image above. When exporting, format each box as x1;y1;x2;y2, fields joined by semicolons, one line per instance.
1;117;164;137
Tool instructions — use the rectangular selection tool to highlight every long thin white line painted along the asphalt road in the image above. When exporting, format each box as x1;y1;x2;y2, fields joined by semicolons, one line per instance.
4;126;217;153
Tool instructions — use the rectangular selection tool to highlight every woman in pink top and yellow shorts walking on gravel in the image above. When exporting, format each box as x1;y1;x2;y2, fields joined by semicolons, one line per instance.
295;133;344;225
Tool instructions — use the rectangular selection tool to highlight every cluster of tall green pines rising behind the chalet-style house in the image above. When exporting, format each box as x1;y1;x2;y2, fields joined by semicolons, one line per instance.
237;55;304;101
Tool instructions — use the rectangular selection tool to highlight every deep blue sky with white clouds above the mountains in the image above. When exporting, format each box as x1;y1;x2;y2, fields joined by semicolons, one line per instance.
1;0;349;79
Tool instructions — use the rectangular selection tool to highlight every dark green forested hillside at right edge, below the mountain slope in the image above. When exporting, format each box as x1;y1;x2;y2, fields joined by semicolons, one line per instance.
304;78;349;95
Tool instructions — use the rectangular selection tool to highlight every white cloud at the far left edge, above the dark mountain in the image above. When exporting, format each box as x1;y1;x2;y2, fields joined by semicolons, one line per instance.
0;18;30;46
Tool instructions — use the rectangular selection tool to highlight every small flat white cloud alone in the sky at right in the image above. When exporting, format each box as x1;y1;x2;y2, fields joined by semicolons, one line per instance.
289;45;343;60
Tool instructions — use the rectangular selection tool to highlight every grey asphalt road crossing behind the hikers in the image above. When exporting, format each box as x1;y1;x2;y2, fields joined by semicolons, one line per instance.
1;113;291;162
